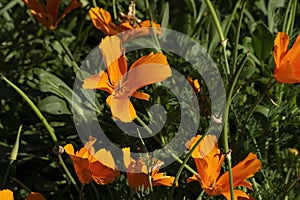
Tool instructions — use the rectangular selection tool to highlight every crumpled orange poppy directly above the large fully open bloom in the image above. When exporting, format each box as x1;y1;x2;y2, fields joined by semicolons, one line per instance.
89;7;160;37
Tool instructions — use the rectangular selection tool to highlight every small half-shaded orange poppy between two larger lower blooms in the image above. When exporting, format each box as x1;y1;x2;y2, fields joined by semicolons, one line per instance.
123;147;175;191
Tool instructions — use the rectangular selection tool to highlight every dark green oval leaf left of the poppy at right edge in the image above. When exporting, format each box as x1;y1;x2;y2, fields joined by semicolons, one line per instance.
252;23;273;61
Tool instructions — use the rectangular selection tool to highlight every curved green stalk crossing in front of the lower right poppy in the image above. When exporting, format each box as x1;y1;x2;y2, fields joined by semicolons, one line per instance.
222;54;248;200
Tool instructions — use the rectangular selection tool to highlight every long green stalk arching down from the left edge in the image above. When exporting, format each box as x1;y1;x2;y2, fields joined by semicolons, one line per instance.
1;74;79;191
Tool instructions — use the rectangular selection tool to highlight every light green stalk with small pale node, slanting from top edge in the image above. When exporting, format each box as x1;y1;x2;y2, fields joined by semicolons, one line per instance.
205;0;230;75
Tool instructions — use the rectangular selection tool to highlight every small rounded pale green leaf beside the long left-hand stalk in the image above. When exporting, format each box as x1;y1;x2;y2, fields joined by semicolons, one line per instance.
38;95;72;115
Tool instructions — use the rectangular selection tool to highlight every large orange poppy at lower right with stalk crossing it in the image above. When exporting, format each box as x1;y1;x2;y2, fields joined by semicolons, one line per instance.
187;137;261;200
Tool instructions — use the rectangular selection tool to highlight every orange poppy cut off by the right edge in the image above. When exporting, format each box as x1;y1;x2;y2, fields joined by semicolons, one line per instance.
274;32;300;83
